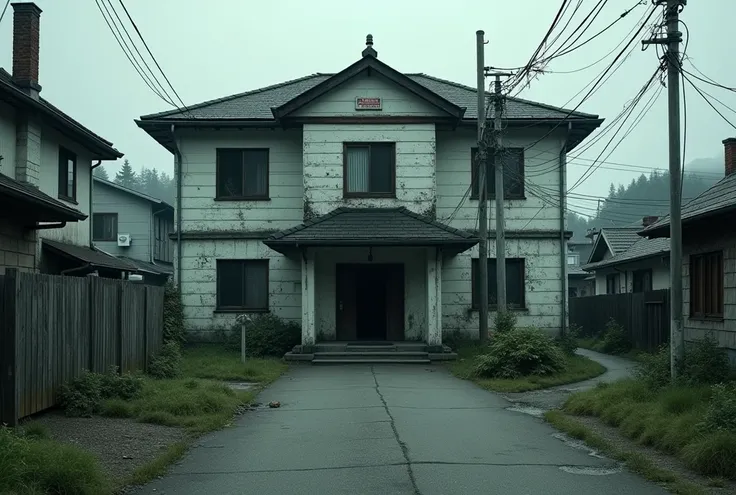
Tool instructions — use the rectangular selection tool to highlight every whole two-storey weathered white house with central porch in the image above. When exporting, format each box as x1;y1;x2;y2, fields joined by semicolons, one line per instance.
137;37;601;346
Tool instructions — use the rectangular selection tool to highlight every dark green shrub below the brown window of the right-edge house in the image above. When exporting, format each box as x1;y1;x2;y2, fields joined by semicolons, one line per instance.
679;337;731;386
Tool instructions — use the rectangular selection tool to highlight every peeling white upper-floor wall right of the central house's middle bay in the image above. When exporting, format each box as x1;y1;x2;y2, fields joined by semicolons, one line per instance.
437;129;563;231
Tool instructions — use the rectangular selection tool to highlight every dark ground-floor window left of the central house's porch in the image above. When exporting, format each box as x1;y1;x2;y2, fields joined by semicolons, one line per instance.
217;260;268;311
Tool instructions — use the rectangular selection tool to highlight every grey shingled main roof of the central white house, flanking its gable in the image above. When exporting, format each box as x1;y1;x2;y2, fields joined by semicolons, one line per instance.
141;73;598;120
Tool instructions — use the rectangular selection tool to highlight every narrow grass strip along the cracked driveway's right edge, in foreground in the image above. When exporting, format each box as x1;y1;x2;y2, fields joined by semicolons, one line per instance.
544;411;707;495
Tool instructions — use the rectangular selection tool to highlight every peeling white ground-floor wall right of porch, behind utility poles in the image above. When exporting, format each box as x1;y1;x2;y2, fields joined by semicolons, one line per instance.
442;239;563;338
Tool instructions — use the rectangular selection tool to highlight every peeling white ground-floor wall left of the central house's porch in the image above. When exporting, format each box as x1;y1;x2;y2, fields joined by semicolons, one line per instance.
180;239;302;340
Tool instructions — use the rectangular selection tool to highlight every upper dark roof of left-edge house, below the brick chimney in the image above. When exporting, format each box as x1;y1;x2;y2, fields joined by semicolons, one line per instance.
0;68;123;160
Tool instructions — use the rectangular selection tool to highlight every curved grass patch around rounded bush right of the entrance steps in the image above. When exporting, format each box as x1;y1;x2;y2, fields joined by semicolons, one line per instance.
450;345;606;393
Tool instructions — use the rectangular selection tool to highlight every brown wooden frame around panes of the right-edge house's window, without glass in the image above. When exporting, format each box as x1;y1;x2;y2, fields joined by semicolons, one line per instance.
688;251;725;320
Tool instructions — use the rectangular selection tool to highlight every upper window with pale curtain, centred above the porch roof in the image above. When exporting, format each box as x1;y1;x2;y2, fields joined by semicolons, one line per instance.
343;143;396;198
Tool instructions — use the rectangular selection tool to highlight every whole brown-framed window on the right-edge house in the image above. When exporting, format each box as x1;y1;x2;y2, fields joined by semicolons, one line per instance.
690;251;723;318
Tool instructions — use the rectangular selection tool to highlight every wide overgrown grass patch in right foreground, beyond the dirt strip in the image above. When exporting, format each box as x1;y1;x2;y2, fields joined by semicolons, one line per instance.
564;380;736;479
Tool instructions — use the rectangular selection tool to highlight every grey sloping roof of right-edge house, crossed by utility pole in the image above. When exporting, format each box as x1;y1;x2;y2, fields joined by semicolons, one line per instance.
639;173;736;237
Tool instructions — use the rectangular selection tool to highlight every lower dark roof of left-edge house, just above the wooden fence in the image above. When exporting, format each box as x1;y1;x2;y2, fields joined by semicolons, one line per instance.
0;173;87;222
